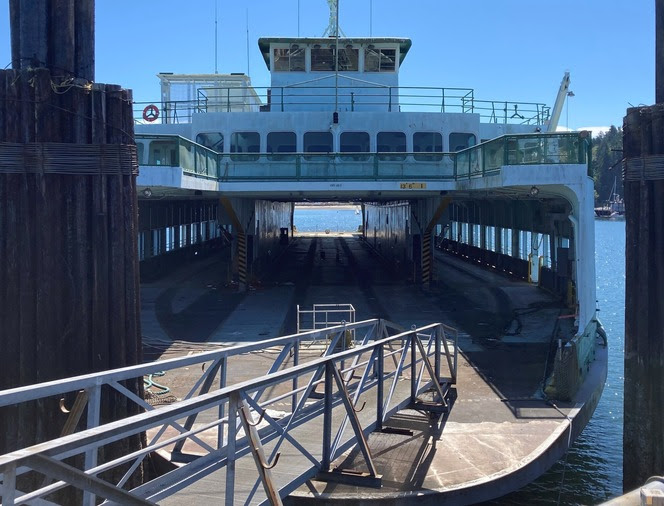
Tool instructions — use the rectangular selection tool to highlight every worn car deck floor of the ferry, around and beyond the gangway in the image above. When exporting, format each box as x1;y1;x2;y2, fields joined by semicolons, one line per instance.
142;234;607;504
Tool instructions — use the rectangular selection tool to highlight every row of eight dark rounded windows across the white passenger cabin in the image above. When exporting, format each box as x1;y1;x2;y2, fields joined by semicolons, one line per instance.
196;131;476;161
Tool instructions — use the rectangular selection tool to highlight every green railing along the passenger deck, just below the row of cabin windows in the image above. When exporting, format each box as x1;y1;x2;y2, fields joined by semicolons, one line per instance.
136;132;591;181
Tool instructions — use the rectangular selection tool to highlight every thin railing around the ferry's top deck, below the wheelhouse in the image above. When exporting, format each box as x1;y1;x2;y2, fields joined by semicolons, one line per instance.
134;86;551;125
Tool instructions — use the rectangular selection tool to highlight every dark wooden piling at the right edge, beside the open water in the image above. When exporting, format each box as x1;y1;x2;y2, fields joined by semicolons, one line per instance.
623;104;664;490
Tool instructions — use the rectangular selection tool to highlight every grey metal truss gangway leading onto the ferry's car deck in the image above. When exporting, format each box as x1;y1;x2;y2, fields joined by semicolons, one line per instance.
0;319;457;505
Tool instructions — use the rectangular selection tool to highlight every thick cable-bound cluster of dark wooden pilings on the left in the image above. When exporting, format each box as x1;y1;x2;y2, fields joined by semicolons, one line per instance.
0;0;142;486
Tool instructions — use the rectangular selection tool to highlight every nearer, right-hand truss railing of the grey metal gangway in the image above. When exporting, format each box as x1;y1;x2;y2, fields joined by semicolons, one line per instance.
0;324;458;505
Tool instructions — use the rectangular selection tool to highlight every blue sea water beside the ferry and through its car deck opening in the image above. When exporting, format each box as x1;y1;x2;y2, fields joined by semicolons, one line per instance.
294;209;625;505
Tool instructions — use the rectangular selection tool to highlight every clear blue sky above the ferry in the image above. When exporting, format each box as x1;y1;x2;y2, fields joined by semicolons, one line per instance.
0;0;655;129
